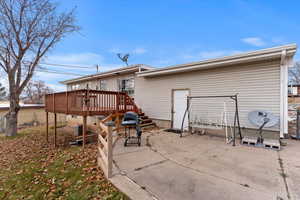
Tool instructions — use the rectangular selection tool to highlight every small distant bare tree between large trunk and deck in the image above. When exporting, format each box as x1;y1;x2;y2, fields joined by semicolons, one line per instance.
23;81;53;104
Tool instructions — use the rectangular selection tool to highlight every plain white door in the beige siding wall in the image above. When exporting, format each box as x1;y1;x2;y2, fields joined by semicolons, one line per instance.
173;90;189;130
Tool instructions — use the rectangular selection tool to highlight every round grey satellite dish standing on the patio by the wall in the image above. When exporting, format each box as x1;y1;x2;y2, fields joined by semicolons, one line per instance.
248;110;279;127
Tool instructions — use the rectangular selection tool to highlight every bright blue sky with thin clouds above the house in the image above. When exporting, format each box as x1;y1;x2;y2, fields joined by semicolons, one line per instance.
35;0;300;90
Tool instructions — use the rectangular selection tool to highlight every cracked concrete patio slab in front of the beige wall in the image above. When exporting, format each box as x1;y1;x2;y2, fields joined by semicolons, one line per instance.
111;131;300;200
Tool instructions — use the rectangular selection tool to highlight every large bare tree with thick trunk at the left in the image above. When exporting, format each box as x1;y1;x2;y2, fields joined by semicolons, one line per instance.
0;0;79;136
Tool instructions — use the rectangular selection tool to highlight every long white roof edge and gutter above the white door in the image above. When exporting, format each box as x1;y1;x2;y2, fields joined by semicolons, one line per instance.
138;44;297;77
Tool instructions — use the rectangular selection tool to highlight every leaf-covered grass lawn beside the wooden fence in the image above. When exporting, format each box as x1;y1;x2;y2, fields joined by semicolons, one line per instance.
0;127;128;200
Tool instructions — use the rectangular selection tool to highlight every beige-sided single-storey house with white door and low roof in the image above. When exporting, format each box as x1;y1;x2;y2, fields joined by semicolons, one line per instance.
62;44;297;137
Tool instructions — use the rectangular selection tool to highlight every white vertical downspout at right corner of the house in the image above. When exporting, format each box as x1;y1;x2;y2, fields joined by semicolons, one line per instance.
280;50;288;138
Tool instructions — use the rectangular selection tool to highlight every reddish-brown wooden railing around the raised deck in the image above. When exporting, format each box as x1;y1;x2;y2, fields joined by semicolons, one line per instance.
45;90;139;116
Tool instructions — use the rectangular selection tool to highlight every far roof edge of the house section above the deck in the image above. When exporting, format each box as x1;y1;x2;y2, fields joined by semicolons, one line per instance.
60;64;153;84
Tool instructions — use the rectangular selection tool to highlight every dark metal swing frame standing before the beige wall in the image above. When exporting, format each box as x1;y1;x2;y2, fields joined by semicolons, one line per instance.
180;94;242;146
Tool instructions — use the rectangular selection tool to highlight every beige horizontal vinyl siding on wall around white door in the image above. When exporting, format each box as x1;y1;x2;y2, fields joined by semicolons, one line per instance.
135;59;280;130
